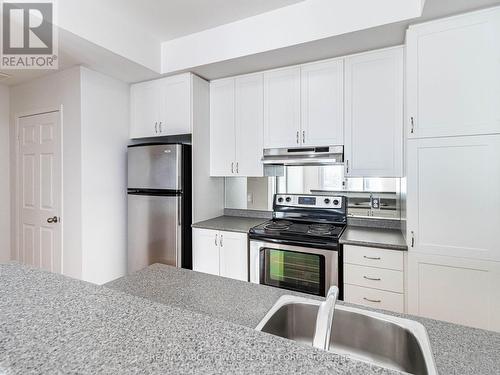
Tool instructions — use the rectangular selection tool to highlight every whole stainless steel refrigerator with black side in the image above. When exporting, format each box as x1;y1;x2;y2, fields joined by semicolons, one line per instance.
128;144;192;273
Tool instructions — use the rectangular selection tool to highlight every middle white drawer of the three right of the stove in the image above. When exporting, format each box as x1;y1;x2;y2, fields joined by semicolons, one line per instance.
344;264;404;293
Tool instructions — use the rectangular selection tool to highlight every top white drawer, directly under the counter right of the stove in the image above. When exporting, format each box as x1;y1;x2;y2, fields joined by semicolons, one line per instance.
344;245;404;271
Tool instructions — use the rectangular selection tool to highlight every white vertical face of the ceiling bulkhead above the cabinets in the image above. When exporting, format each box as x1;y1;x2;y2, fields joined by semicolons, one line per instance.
162;0;422;74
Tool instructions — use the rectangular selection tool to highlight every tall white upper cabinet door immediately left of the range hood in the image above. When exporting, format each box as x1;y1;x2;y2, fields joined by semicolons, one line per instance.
235;74;264;177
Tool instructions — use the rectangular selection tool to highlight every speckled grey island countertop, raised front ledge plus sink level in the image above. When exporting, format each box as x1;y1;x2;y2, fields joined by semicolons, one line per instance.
0;264;500;374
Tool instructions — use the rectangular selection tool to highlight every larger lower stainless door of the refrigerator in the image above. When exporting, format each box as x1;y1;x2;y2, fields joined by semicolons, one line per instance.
128;194;182;273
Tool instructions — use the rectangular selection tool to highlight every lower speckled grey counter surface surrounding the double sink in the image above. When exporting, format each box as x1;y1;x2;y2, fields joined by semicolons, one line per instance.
106;264;500;375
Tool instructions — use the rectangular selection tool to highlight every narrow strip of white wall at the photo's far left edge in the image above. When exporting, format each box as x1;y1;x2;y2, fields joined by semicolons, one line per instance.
0;85;11;263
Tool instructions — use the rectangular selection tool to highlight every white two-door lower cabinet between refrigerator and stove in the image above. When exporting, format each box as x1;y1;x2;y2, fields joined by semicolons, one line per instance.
193;228;248;281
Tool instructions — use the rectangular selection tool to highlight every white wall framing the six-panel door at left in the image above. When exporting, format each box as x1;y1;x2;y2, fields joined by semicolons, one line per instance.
10;67;82;278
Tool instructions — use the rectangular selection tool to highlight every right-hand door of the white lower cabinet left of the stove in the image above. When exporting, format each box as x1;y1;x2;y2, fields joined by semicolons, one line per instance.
220;232;248;281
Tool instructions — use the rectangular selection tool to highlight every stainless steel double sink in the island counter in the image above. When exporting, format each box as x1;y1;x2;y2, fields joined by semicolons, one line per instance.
256;296;437;375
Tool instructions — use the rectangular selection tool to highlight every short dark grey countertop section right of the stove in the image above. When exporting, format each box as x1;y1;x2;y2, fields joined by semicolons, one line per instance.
340;225;408;251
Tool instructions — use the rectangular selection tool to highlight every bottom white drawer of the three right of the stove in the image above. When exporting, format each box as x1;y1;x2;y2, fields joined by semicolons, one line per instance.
344;284;404;313
